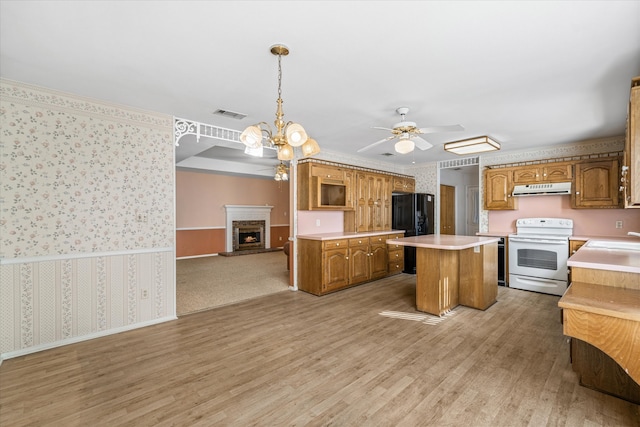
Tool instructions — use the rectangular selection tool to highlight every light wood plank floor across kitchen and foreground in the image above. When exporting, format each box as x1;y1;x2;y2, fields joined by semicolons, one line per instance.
0;275;640;427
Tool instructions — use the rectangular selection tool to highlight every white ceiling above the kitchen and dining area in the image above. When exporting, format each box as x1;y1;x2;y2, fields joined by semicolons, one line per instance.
0;0;640;174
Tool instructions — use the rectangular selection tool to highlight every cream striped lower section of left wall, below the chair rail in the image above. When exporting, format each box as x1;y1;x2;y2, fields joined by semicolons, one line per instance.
0;248;176;359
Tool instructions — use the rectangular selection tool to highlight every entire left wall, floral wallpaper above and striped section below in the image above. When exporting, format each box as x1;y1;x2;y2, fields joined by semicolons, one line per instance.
0;79;175;358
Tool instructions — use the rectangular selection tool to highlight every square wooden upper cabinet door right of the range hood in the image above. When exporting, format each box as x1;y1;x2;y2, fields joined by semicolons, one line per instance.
571;160;619;208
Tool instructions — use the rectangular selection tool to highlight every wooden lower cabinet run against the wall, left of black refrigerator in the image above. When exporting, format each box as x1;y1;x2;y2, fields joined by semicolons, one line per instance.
298;233;404;295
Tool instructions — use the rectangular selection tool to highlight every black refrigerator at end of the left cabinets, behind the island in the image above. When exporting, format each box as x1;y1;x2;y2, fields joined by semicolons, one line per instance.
391;193;435;274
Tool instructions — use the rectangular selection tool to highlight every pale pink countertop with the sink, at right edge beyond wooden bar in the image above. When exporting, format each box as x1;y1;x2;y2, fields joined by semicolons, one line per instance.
567;237;640;273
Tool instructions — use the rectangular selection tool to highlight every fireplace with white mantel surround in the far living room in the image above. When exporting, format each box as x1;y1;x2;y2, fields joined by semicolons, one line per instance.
224;205;273;252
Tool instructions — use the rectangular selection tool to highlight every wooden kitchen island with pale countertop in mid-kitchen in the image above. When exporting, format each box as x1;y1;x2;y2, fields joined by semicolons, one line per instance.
387;234;500;316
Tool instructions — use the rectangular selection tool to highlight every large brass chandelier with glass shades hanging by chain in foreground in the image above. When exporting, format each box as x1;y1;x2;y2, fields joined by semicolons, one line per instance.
240;44;320;162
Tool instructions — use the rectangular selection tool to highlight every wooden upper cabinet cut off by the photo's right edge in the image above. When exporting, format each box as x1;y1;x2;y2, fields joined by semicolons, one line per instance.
622;76;640;208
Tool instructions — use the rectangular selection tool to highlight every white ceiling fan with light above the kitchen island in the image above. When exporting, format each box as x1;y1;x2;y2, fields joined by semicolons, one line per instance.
357;107;464;154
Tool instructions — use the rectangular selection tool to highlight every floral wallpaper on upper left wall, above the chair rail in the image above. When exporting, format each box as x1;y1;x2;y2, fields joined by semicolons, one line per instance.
0;80;174;258
